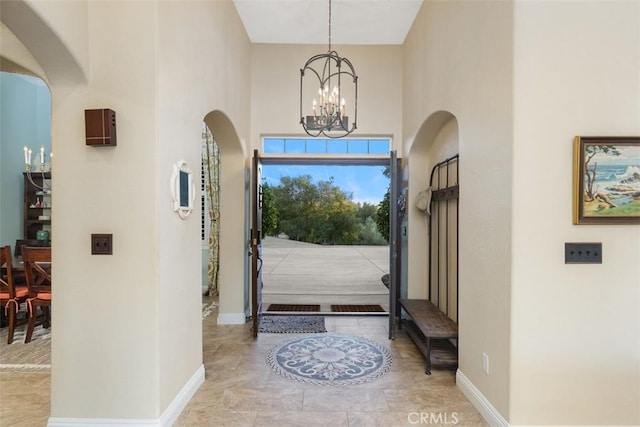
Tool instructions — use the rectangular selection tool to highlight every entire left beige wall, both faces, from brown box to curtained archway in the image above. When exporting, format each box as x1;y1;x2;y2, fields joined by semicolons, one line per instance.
1;1;250;420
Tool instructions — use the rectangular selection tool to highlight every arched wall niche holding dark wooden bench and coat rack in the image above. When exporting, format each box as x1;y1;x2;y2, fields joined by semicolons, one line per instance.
400;111;459;374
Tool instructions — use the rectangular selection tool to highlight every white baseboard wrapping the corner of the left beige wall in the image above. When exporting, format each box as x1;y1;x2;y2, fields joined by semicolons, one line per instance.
47;365;204;427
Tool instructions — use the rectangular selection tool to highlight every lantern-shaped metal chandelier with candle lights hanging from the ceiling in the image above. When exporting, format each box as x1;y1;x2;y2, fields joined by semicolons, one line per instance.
300;0;358;138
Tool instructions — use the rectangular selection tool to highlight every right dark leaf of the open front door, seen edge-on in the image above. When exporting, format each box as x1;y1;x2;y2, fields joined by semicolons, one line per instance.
389;151;404;339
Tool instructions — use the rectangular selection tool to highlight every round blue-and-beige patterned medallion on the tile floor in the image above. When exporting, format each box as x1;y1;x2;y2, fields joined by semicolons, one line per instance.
267;333;391;386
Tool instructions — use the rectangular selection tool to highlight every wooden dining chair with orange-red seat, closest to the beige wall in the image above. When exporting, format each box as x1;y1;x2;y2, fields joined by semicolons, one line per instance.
22;246;51;343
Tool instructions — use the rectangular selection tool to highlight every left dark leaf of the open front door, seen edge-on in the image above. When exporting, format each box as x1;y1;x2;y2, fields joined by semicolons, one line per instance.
251;150;262;337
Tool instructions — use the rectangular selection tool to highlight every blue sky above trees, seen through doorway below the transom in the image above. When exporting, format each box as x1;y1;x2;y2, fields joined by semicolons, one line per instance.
262;165;389;205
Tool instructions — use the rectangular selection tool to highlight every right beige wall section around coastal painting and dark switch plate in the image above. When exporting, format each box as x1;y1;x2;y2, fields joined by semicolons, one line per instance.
509;1;640;425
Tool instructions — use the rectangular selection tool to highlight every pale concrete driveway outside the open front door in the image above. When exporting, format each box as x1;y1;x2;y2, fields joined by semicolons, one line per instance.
262;237;389;312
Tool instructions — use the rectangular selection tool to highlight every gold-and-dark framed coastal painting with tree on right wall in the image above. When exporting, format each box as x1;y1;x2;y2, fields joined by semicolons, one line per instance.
573;136;640;224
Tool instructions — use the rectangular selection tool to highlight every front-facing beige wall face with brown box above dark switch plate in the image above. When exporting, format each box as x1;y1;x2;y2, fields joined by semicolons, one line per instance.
51;2;162;418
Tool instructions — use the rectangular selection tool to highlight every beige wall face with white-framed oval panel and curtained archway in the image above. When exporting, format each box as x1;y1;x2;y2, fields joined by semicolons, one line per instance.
156;1;250;408
